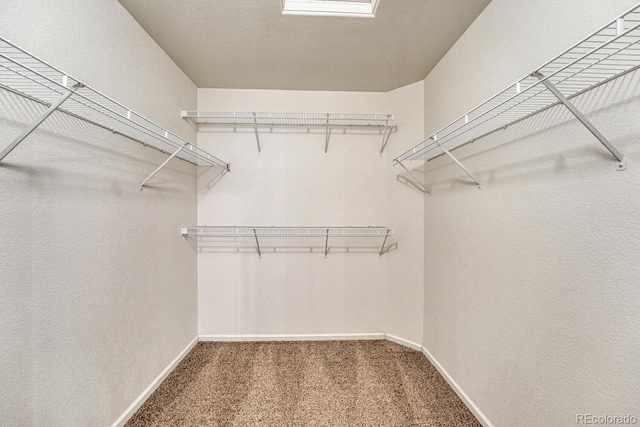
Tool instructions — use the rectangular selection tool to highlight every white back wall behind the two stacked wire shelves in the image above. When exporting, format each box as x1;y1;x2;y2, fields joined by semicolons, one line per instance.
198;82;423;341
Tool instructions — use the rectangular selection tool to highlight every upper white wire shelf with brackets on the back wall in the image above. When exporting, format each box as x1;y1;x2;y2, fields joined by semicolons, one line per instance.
182;110;398;154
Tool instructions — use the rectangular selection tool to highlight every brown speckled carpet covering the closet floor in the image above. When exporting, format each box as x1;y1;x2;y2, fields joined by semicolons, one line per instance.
126;341;480;427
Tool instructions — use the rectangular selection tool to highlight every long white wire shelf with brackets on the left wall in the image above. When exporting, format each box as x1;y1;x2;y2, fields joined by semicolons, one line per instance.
0;37;229;190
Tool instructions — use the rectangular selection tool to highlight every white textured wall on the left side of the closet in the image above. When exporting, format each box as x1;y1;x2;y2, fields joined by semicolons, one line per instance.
0;0;197;426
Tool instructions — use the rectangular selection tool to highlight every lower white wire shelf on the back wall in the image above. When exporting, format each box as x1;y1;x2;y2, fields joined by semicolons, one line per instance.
180;226;398;257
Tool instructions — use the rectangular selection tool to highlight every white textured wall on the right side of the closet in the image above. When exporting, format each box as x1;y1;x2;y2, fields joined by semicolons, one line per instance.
423;0;640;426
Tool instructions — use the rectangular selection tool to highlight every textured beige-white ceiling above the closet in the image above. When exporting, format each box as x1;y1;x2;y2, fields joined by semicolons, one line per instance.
118;0;490;92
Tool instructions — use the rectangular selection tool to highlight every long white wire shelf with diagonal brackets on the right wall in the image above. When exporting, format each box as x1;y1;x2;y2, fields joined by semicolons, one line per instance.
394;5;640;191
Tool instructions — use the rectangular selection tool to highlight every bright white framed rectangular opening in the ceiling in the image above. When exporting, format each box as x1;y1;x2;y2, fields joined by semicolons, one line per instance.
281;0;380;18
